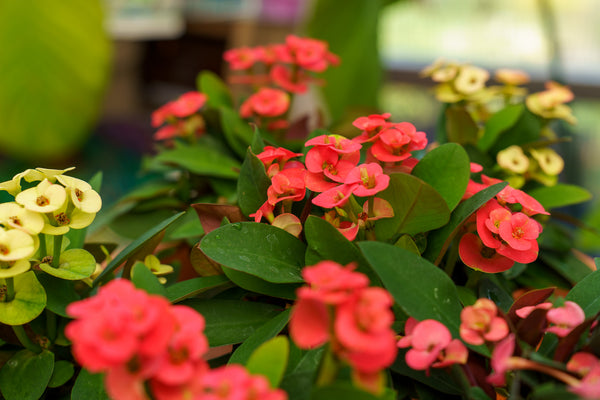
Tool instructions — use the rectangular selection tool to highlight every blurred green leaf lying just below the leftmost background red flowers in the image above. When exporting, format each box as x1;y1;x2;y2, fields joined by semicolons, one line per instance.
154;142;240;179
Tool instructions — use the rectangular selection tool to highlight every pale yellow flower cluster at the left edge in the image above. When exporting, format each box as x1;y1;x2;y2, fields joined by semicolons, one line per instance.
0;168;102;278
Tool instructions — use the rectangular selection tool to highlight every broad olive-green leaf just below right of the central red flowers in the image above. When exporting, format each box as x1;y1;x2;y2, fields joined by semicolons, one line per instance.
375;174;450;241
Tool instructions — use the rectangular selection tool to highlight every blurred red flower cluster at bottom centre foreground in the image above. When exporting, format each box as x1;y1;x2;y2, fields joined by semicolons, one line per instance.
290;261;397;392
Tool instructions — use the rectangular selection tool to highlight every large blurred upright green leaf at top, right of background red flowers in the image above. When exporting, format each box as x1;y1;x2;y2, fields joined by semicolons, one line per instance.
306;0;382;120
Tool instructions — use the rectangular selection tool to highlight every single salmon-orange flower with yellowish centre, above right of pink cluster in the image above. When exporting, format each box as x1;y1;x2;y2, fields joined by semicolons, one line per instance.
460;299;508;345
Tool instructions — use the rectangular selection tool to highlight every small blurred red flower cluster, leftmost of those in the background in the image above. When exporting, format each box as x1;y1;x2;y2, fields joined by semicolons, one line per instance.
152;91;208;140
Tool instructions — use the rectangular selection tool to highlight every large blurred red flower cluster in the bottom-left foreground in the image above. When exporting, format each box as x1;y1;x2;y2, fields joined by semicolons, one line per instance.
65;279;286;400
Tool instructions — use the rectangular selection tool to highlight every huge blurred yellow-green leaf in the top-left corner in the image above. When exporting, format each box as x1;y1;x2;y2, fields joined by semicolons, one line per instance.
0;0;111;164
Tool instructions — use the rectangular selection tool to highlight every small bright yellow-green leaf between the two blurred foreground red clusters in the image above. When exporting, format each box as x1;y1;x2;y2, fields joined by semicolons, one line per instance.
246;336;290;388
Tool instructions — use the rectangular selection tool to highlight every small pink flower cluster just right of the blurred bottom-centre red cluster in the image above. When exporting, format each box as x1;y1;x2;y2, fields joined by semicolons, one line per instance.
397;317;469;371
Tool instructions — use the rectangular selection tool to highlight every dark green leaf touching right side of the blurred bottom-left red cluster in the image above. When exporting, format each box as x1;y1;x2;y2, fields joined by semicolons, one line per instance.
182;299;281;347
